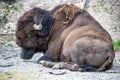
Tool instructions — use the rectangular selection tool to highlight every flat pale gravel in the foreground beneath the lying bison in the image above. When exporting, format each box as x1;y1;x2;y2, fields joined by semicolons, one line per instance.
0;50;120;80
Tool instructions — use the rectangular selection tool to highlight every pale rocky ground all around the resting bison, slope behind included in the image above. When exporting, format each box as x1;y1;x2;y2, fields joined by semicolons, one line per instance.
0;0;120;80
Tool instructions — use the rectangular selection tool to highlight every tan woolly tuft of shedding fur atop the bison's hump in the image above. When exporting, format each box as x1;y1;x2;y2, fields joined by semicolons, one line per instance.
61;4;83;22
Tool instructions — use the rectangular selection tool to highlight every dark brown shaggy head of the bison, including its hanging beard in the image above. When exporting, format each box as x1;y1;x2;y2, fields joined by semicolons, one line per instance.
16;8;53;59
